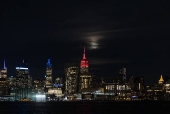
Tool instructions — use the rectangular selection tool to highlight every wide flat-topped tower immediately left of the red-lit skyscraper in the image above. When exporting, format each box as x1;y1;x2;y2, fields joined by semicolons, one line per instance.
65;64;79;95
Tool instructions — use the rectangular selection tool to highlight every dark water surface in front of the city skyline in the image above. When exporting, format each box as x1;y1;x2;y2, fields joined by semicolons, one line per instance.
0;101;170;114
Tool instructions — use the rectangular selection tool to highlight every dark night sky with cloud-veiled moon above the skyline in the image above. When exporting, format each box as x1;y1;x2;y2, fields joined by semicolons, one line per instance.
0;0;170;83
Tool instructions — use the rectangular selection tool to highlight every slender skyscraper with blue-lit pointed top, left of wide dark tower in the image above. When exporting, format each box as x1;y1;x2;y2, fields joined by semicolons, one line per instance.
45;59;53;88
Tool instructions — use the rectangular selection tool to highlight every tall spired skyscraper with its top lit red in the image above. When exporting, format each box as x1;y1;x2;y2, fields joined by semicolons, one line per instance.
79;47;92;91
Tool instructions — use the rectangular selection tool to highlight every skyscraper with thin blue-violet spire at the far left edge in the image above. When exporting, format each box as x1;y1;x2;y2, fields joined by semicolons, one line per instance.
0;60;8;95
